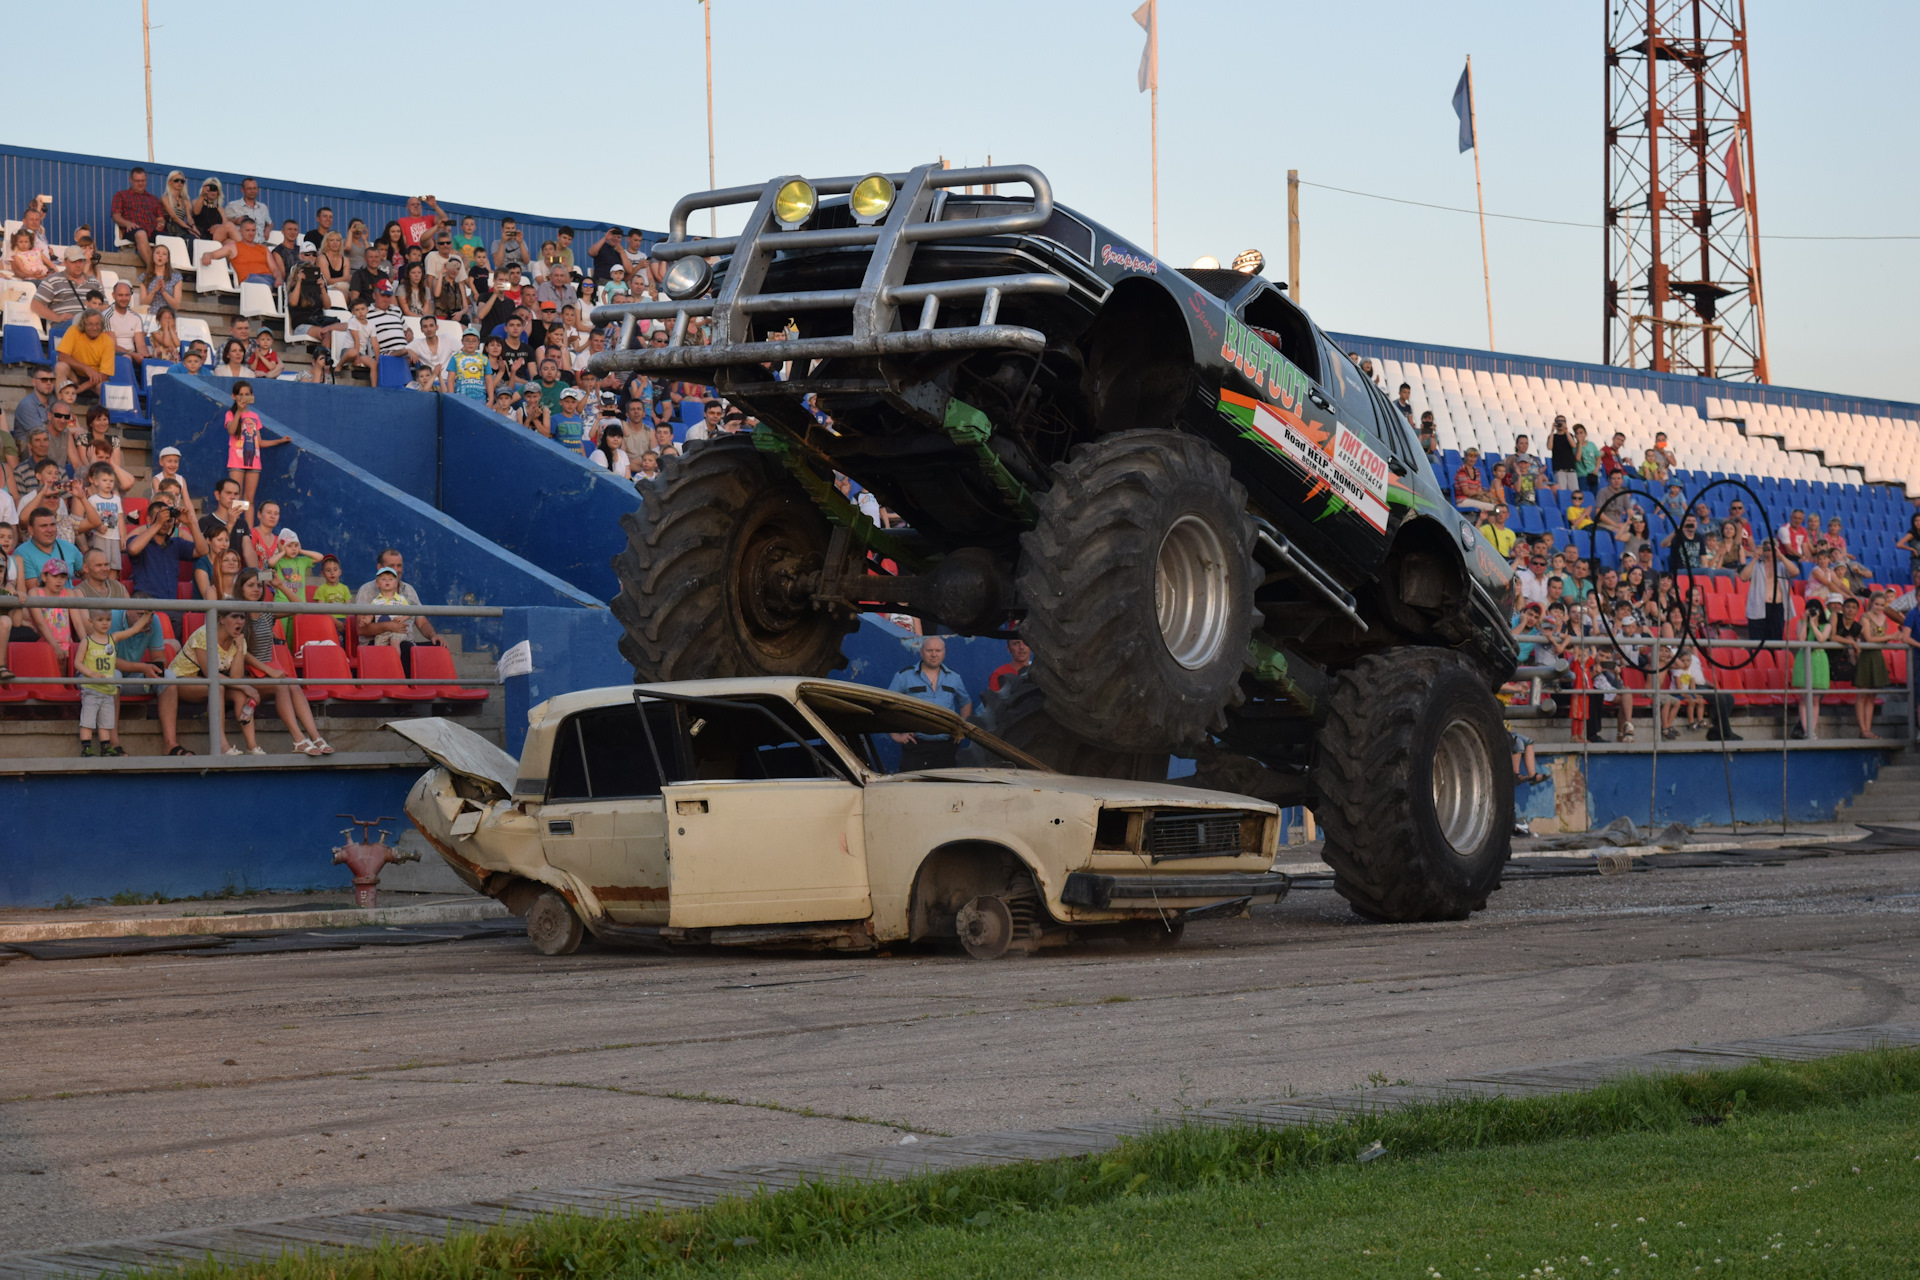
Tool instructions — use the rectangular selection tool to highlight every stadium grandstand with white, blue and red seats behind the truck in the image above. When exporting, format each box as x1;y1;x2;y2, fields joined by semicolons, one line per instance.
0;148;1920;905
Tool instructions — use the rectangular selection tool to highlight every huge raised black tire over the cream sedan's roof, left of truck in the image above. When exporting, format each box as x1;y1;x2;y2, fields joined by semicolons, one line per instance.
612;436;858;683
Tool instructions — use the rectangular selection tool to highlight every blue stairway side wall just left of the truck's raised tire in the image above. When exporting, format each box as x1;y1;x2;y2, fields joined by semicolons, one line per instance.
439;391;639;601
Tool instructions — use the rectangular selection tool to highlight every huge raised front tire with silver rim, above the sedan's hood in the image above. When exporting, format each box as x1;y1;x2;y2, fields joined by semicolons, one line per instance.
1020;432;1260;752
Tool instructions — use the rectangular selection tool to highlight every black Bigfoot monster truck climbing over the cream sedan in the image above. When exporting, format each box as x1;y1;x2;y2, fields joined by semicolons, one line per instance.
591;165;1515;921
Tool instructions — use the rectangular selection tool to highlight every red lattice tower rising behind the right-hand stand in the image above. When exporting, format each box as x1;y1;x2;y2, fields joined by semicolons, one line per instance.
1601;0;1768;382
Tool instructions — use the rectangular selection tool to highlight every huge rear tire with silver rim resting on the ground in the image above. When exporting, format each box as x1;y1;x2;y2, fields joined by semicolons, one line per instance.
1313;649;1513;921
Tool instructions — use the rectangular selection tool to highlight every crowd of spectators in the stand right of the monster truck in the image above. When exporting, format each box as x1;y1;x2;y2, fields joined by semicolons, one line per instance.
1451;418;1920;743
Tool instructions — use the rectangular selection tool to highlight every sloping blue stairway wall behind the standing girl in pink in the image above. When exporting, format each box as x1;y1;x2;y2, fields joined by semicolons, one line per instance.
154;372;605;645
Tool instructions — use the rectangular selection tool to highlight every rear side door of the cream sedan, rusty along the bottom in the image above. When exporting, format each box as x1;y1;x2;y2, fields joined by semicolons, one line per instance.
538;702;672;925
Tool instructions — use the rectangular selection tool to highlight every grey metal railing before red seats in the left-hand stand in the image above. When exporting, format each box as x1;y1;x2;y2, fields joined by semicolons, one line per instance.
0;595;507;756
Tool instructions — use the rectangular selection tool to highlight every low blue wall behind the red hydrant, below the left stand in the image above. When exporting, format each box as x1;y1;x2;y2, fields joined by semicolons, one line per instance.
0;768;420;908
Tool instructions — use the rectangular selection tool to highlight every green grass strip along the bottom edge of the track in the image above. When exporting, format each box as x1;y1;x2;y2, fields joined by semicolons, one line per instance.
135;1050;1920;1280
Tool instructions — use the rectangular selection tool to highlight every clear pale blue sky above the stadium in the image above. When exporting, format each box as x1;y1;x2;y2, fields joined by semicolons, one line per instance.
6;0;1920;399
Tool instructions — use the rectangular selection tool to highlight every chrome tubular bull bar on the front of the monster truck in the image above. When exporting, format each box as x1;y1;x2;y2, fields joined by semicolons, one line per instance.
588;165;1069;374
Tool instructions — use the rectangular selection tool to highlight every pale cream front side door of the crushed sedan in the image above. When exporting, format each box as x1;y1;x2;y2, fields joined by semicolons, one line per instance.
660;699;874;929
